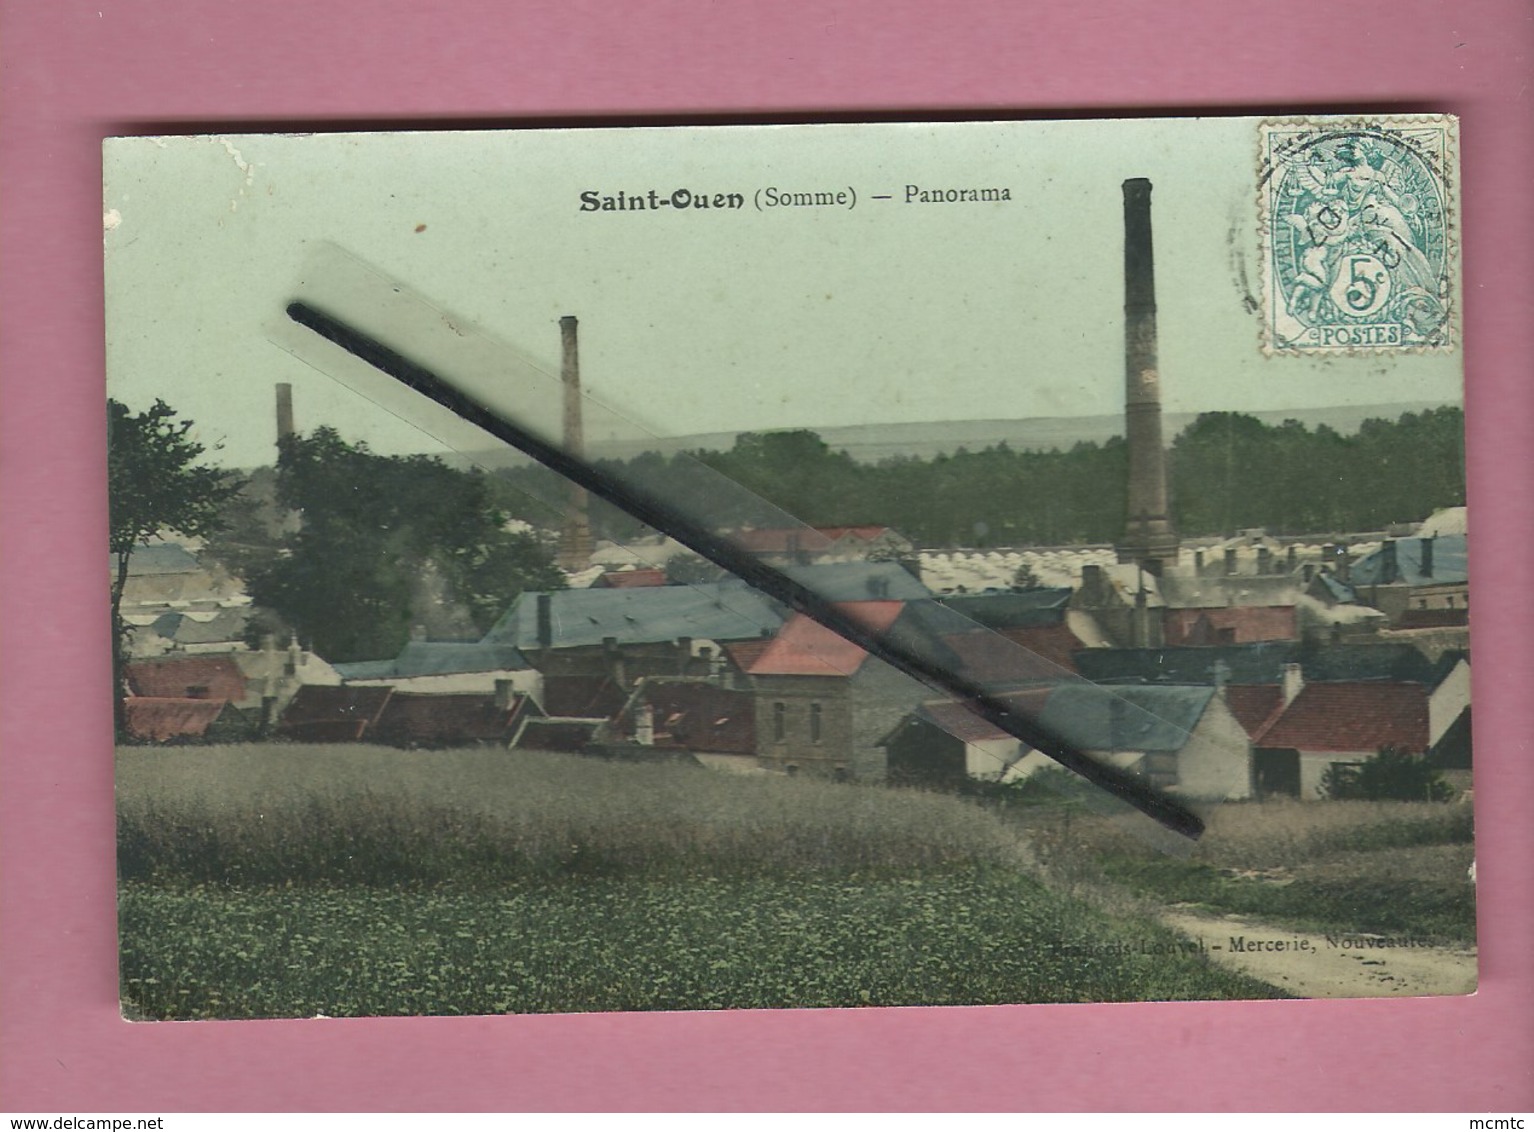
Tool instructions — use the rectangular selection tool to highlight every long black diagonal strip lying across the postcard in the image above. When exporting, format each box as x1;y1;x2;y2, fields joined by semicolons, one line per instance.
287;302;1204;837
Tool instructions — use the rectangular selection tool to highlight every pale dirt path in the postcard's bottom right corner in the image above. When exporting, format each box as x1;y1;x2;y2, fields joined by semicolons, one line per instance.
1160;910;1476;999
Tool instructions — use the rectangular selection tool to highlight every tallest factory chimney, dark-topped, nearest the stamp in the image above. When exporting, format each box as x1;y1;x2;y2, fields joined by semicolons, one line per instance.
1114;178;1178;574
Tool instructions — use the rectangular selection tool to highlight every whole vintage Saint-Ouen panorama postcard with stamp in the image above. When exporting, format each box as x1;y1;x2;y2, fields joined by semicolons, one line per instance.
103;114;1476;1020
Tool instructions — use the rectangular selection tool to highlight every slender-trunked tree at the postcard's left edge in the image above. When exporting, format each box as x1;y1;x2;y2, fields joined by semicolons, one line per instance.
106;400;242;735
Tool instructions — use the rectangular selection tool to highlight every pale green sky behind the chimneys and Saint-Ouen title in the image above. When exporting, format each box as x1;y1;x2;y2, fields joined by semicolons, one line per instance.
104;118;1462;466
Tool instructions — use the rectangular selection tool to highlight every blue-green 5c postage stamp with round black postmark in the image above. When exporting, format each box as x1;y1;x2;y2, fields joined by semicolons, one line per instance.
1258;115;1457;354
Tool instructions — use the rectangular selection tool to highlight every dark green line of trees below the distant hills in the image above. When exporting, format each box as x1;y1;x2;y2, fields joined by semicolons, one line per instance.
499;406;1465;546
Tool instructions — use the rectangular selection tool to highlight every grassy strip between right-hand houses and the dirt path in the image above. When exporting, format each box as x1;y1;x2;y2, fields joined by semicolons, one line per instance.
1034;802;1476;945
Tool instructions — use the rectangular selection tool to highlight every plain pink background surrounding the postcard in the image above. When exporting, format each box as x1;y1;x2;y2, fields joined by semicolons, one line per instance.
0;0;1534;1112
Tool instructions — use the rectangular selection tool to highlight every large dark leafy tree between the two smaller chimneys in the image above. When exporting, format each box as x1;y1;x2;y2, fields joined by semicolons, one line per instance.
247;428;565;661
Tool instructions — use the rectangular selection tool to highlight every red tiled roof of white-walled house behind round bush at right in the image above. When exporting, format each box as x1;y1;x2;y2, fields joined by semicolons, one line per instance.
1252;683;1428;752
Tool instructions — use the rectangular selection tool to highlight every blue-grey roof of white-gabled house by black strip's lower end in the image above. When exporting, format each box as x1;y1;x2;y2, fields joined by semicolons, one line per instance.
1039;683;1215;752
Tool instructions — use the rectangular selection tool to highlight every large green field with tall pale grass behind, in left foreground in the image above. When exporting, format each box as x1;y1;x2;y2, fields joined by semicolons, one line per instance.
118;745;1276;1018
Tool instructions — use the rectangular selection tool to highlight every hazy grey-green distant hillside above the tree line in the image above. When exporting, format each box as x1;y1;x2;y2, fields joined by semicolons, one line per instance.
460;400;1439;468
